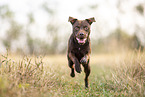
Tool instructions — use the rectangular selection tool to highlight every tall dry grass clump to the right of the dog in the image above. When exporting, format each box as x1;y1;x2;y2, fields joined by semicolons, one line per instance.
112;52;145;97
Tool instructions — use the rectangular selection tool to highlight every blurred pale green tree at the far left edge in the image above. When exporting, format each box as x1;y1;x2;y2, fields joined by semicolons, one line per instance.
0;5;23;50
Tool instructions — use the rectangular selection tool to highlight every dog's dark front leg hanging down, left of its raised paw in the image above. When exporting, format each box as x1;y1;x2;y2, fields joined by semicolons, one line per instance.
69;53;82;73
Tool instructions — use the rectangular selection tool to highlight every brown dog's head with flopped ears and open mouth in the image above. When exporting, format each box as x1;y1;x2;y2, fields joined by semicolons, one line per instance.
69;17;95;45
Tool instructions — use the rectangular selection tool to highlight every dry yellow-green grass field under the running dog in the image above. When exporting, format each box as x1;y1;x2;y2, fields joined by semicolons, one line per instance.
0;52;145;97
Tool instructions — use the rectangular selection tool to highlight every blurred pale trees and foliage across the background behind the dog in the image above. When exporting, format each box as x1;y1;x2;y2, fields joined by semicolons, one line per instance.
0;0;145;55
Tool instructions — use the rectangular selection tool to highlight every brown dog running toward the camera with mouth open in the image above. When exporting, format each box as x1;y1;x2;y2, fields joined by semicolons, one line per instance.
67;17;95;88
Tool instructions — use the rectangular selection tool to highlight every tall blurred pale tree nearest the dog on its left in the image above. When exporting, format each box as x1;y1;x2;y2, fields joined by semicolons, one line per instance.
42;2;63;54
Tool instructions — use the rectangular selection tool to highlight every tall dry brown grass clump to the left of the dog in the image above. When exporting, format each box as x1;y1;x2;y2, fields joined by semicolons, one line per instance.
0;55;64;97
